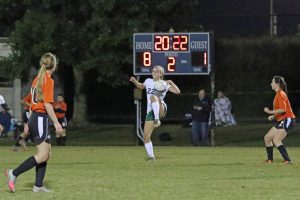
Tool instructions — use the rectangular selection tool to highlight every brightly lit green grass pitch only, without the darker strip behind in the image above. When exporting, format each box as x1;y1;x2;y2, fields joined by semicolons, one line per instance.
0;146;300;200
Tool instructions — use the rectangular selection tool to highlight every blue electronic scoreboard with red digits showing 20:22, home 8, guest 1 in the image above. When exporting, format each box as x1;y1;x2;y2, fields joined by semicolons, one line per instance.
133;32;212;75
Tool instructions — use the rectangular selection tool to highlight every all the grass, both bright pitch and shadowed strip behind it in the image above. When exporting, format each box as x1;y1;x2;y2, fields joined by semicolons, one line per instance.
0;124;300;200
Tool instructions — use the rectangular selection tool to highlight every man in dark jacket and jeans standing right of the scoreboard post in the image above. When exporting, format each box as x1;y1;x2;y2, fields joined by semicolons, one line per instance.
192;89;211;146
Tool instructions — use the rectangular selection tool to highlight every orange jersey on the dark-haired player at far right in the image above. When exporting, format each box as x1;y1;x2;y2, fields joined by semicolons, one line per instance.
273;90;295;121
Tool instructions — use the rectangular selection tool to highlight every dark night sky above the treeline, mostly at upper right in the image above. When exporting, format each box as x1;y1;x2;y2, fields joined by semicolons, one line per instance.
0;0;300;37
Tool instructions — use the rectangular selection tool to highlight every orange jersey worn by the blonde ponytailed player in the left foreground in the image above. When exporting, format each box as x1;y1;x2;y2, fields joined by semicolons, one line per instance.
31;73;54;113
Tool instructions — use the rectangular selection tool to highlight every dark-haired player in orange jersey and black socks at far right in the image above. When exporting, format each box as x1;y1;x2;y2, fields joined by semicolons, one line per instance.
264;76;295;164
